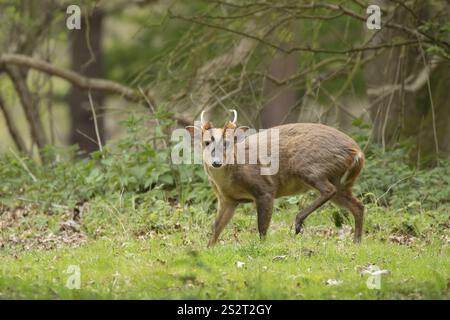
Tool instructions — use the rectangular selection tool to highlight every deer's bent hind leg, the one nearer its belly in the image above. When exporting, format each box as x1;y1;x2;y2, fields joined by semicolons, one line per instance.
295;179;337;234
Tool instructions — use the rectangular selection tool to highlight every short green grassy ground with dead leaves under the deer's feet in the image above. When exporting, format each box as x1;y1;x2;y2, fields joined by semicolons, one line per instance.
0;202;450;299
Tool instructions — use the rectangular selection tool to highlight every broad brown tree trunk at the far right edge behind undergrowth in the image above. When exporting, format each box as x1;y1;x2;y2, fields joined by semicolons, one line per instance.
365;0;450;159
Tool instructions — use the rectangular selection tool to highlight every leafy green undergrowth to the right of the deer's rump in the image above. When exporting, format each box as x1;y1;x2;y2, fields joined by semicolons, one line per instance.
352;120;450;211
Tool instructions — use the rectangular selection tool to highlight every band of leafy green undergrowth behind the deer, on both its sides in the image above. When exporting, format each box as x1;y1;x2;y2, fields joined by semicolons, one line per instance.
0;117;450;212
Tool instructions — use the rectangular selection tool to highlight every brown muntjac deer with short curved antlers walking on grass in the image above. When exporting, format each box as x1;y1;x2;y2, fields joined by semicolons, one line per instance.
187;110;364;246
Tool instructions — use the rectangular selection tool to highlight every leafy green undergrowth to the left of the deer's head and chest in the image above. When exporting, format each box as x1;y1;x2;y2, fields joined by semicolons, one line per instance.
0;109;212;209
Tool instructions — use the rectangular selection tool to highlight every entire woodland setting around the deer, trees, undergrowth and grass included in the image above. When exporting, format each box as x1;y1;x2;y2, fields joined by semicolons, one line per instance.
0;0;450;299
